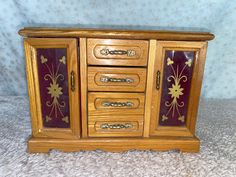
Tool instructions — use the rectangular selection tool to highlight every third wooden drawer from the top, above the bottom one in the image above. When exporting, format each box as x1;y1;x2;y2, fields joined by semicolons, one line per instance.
88;92;144;116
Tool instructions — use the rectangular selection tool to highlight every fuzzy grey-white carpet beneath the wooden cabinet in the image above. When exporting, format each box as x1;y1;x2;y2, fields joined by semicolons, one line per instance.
0;97;236;177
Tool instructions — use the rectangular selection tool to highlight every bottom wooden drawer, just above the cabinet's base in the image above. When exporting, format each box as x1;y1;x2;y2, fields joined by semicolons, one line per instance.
88;115;143;137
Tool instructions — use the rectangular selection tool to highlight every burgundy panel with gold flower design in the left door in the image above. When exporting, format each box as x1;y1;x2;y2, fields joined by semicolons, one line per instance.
37;48;70;128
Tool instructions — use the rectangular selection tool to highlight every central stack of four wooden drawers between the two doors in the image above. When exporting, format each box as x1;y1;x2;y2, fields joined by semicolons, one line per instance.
87;38;149;137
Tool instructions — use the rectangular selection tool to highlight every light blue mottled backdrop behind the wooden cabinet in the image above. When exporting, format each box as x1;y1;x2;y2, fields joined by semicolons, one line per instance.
0;0;236;98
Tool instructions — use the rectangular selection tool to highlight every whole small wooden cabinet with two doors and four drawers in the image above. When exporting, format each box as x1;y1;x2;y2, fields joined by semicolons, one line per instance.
19;28;214;152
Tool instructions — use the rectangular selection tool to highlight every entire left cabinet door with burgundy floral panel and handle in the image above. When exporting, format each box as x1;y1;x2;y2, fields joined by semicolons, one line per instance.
24;38;80;139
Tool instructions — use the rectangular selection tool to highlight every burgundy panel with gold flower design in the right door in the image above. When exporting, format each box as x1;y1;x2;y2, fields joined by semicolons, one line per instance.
159;50;195;126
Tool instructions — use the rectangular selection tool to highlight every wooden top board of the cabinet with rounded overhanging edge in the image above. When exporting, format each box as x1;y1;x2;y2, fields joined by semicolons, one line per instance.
19;26;214;41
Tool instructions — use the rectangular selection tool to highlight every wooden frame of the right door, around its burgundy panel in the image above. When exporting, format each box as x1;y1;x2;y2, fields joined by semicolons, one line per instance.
146;41;207;137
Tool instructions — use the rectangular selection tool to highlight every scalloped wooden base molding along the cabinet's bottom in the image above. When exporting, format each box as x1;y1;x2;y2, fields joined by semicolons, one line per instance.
28;137;200;153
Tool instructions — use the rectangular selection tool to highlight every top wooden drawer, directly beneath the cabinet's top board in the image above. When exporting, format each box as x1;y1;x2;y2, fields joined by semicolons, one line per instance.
87;39;148;66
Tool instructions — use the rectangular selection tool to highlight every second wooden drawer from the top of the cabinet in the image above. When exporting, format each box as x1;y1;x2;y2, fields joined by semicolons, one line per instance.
88;67;146;92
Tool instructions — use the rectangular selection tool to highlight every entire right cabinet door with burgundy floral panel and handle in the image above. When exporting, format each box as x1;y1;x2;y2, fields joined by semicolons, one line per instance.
150;41;207;136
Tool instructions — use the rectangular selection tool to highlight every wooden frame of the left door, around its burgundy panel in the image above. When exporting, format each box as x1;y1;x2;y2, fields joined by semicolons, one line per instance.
24;38;80;139
